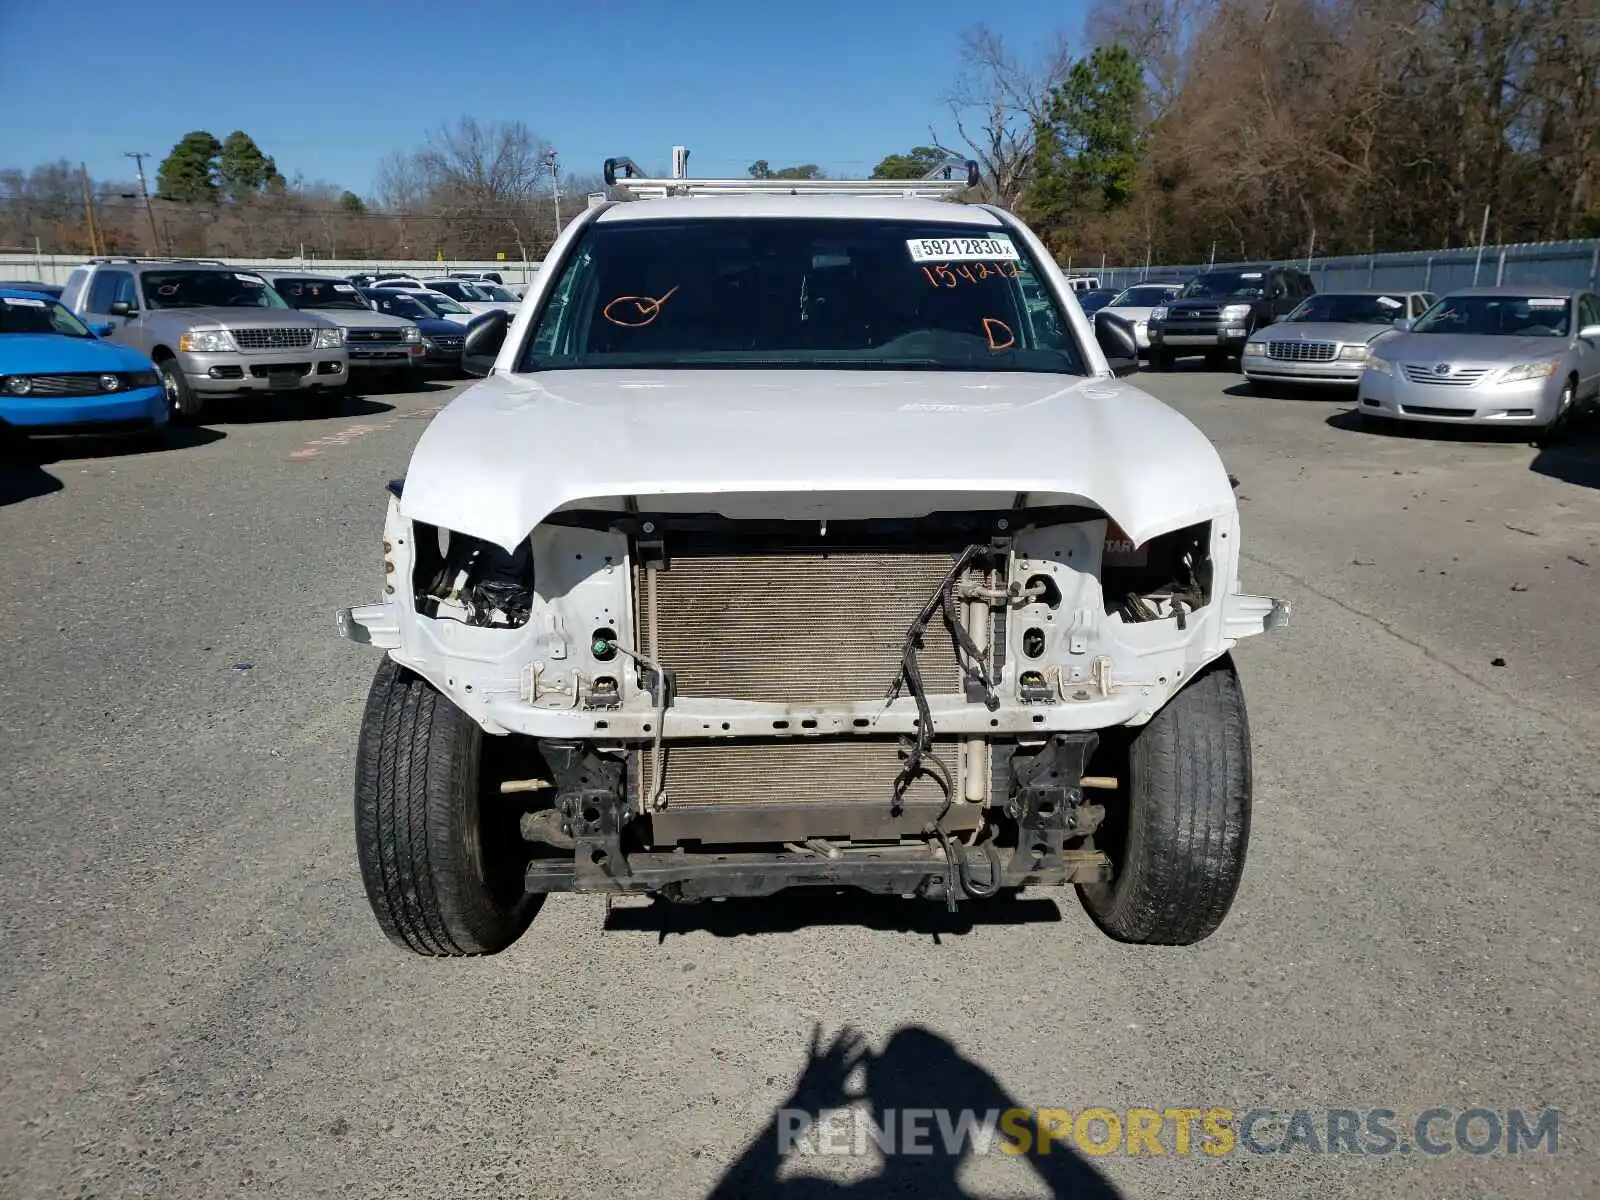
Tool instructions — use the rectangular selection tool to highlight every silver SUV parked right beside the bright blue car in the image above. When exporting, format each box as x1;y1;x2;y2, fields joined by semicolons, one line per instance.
61;258;350;419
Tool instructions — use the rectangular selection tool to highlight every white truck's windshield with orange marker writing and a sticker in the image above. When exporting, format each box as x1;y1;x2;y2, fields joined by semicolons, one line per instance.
520;218;1086;374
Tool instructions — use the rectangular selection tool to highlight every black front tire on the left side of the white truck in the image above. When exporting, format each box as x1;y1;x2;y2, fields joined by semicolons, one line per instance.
355;656;544;957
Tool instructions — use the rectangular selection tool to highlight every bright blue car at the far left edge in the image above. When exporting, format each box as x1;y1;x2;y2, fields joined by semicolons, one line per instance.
0;288;168;435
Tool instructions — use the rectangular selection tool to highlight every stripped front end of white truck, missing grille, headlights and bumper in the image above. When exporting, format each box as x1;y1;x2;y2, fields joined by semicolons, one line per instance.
341;486;1288;904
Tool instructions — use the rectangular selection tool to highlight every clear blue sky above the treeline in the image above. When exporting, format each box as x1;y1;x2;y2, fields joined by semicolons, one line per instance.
0;0;1083;192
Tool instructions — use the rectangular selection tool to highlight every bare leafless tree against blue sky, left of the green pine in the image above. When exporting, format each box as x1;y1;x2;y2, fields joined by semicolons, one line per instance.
931;24;1072;208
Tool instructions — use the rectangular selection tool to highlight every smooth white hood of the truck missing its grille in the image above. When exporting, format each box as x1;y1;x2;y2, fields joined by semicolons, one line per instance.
400;370;1234;549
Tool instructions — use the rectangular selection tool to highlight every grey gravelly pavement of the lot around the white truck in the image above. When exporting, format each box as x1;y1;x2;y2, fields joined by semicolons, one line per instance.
0;370;1600;1200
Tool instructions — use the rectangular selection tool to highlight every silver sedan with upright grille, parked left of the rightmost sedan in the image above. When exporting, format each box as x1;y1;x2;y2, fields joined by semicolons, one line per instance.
1238;291;1434;389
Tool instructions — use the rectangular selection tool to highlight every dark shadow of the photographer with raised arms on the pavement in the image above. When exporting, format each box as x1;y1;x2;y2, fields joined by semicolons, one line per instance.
707;1026;1122;1200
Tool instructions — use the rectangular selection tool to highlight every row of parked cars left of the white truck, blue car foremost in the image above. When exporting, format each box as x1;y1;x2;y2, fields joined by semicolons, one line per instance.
0;258;518;448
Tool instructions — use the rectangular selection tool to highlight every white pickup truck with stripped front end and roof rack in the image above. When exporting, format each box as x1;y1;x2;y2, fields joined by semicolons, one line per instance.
339;160;1288;955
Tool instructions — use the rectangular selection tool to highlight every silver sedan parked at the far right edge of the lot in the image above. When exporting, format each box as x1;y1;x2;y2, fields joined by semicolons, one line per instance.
1357;286;1600;440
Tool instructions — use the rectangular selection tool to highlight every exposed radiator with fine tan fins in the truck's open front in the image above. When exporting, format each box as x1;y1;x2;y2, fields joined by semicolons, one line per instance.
634;534;997;810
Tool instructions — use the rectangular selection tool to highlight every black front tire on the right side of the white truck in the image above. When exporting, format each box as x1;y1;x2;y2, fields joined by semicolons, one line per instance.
1078;654;1251;946
